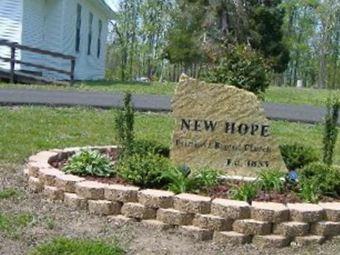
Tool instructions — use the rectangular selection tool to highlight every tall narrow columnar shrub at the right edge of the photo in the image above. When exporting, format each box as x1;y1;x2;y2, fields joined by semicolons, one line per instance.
323;99;340;166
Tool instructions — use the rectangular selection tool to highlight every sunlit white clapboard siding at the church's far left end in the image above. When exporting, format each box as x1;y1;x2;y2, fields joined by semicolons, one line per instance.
0;0;23;69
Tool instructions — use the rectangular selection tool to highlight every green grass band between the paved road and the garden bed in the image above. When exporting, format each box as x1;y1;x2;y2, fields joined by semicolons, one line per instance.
0;107;340;164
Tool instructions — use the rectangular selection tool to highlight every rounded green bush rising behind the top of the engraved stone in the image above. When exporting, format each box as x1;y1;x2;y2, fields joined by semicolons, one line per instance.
205;45;269;94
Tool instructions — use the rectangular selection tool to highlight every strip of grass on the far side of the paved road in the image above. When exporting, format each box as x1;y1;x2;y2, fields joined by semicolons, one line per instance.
0;81;340;106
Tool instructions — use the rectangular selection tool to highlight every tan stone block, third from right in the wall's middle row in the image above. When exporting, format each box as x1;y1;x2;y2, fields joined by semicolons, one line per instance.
233;219;272;235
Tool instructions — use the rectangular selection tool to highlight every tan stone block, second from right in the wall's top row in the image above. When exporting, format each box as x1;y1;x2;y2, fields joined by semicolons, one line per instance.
287;203;324;222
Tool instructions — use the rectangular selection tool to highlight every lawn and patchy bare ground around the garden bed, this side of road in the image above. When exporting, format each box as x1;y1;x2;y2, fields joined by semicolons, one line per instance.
0;107;340;255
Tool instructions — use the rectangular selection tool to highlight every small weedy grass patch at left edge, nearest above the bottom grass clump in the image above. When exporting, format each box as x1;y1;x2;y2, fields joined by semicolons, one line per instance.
0;212;33;239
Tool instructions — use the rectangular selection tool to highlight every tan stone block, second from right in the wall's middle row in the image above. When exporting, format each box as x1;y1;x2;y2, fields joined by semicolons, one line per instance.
273;221;310;237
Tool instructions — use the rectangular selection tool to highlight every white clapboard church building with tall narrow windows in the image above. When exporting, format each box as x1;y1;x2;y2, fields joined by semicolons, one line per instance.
0;0;114;80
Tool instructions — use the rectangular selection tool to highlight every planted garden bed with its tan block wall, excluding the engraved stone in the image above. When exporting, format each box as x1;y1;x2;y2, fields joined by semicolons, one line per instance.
25;92;340;247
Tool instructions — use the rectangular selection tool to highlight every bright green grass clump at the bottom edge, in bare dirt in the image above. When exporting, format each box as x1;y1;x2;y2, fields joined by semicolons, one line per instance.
29;237;124;255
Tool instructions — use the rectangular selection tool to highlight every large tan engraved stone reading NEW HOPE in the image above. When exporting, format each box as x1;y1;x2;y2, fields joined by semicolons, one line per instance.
171;75;287;176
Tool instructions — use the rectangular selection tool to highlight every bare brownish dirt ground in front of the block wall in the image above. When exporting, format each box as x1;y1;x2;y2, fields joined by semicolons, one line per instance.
0;165;340;255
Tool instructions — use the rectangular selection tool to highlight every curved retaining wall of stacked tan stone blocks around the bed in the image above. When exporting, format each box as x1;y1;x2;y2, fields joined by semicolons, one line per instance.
26;147;340;247
